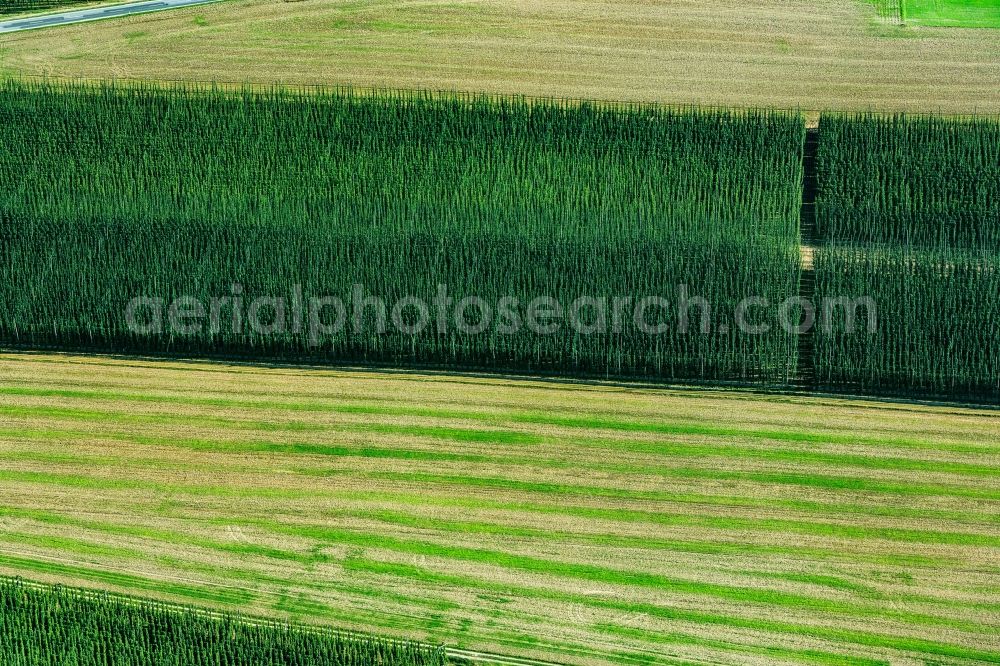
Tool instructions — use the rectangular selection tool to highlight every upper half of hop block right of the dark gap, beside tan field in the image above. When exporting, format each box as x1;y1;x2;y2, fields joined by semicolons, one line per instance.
817;115;1000;251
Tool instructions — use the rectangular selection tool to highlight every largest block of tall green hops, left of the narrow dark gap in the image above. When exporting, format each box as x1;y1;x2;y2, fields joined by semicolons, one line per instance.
0;83;804;383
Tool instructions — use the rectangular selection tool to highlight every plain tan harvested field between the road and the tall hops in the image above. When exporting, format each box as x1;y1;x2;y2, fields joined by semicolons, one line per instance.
0;0;1000;114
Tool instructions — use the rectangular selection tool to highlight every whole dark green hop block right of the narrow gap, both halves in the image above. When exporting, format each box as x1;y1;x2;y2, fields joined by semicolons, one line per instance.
815;116;1000;400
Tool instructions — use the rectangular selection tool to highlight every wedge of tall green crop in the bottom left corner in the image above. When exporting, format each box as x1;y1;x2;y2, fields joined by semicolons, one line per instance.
0;579;449;666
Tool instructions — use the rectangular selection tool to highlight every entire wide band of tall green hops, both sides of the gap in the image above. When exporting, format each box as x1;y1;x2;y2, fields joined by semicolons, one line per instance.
0;82;1000;403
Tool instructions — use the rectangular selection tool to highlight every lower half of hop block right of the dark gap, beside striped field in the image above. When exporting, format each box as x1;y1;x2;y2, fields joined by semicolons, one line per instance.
816;246;1000;401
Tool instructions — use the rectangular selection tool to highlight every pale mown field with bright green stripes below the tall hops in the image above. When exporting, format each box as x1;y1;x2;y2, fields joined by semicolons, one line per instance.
0;354;1000;664
